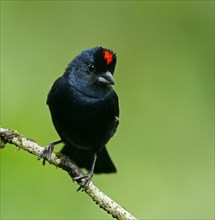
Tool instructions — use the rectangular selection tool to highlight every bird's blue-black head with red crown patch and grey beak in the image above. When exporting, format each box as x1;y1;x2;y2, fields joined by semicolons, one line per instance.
65;47;116;87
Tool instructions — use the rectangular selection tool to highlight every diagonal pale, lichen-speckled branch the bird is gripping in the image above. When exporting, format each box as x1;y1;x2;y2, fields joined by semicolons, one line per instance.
0;128;136;219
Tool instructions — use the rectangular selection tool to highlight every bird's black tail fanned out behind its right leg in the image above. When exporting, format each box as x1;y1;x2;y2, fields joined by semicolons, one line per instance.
61;144;116;173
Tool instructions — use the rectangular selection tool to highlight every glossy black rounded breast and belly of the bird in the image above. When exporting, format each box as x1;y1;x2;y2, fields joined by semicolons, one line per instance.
49;85;117;149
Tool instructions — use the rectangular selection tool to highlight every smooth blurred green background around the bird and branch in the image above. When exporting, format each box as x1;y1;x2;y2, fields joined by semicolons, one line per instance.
0;1;214;219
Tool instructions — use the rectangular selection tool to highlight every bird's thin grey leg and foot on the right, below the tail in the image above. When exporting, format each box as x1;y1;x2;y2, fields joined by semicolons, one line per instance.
73;153;97;191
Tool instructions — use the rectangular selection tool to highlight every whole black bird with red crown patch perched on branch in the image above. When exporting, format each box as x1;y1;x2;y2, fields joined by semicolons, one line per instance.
41;47;119;189
